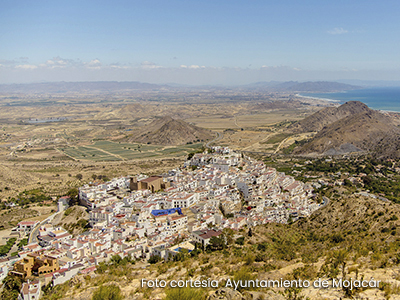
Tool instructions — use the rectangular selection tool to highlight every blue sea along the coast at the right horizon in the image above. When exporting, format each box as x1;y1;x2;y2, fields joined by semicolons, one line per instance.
300;87;400;112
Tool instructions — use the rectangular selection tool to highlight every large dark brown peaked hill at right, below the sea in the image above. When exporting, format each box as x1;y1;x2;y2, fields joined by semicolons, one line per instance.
295;102;400;158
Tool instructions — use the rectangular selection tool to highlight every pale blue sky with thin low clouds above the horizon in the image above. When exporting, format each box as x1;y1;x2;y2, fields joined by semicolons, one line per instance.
0;0;400;85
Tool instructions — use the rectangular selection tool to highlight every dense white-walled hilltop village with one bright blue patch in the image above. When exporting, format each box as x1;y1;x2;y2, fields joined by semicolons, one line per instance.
1;147;323;299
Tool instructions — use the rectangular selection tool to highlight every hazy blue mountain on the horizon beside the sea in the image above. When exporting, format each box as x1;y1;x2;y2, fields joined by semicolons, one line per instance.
246;81;362;93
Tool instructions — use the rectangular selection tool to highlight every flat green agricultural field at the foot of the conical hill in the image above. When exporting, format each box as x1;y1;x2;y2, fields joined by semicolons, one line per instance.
58;141;203;161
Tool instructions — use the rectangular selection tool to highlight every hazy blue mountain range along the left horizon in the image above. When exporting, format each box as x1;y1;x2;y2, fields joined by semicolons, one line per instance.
0;81;166;93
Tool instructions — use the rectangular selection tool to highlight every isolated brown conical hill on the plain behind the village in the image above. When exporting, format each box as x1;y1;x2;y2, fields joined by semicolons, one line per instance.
128;117;213;145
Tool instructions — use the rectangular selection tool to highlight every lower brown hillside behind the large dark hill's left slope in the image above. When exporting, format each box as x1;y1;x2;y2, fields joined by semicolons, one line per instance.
289;101;370;133
